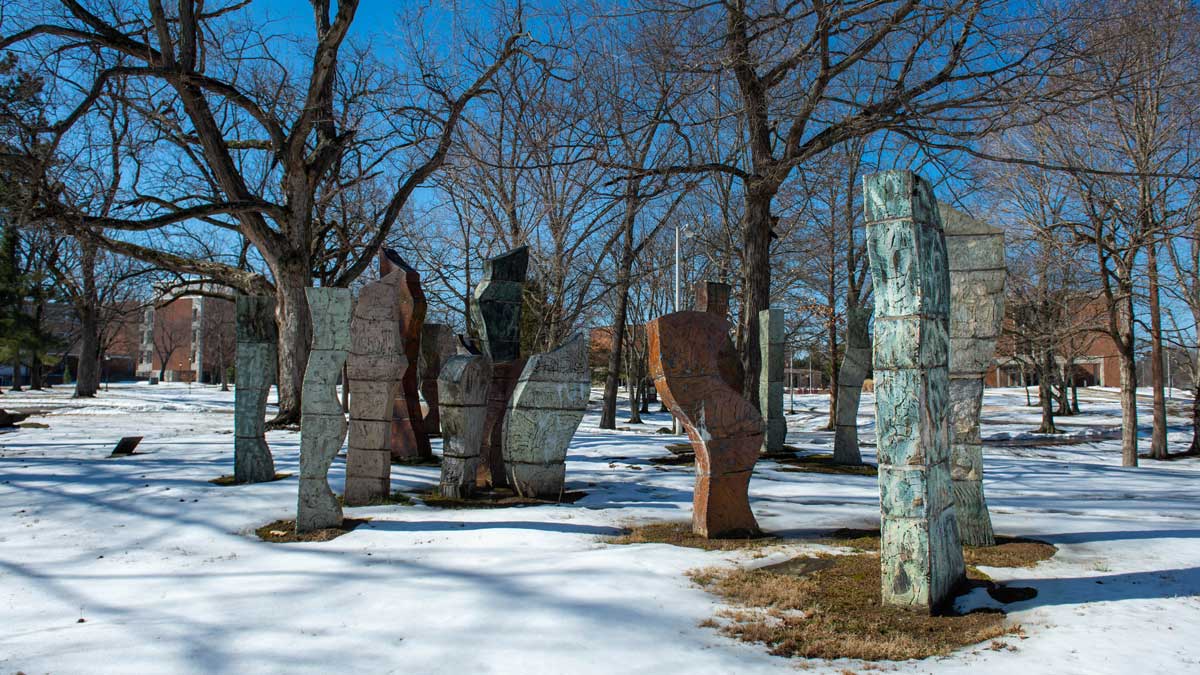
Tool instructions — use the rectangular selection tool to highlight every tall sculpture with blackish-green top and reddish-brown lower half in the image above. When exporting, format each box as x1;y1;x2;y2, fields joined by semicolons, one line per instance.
470;246;529;488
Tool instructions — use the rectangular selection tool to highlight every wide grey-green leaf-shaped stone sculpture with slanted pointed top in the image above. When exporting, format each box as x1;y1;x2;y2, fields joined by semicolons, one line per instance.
503;333;592;500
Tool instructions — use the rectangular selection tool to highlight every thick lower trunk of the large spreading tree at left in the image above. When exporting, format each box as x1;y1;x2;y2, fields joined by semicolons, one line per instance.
266;265;312;429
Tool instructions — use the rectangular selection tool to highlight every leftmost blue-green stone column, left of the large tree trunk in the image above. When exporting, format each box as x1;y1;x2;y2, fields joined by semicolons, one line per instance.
233;295;278;483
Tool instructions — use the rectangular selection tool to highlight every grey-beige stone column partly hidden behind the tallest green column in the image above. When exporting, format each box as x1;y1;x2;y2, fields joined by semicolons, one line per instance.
941;204;1007;546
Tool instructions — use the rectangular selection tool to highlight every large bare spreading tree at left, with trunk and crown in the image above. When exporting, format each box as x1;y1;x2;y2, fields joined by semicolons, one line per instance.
0;0;522;423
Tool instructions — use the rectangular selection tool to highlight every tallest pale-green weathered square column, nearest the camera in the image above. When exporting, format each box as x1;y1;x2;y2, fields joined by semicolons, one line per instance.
863;171;964;611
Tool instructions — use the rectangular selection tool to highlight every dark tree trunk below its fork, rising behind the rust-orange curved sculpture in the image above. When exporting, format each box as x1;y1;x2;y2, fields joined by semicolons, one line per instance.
738;183;775;408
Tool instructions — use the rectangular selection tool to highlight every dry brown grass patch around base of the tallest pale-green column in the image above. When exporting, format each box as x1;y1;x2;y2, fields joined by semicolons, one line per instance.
689;552;1020;661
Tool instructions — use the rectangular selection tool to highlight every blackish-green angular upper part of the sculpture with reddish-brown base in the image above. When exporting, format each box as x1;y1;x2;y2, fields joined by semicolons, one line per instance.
470;246;529;363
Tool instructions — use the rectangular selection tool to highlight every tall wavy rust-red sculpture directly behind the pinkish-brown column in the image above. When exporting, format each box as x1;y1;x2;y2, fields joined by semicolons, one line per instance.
379;249;433;461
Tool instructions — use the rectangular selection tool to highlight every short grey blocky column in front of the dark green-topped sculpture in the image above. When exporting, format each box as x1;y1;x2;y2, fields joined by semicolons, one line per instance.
438;354;492;500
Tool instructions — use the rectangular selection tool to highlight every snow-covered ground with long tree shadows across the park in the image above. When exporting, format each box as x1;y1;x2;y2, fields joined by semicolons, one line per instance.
0;384;1200;675
